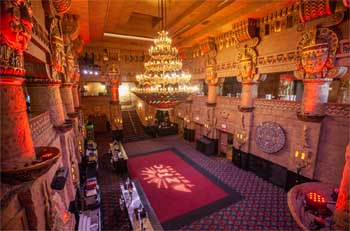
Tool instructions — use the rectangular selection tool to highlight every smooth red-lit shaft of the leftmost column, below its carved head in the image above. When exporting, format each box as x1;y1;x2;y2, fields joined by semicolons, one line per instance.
0;77;36;171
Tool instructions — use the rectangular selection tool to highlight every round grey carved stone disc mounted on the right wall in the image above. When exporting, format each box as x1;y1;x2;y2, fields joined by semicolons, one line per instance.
255;122;286;154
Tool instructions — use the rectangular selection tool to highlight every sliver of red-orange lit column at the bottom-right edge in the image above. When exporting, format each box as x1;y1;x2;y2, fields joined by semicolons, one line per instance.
334;144;350;230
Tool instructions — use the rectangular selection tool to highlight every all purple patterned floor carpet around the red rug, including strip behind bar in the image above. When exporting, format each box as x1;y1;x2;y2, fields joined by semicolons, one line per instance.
96;135;299;230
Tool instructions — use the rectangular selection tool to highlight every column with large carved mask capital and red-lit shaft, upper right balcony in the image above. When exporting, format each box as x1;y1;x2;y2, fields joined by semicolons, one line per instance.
295;28;347;120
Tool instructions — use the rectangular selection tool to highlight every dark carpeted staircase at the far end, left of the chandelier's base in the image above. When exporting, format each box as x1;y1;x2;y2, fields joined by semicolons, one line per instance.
122;110;151;143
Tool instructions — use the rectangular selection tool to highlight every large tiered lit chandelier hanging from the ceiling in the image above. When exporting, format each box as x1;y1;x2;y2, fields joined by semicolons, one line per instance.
131;0;197;108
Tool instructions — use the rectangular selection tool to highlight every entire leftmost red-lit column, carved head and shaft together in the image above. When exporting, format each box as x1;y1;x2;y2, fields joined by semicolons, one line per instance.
0;1;35;171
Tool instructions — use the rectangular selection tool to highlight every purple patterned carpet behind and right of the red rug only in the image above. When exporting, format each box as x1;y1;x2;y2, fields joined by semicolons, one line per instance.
125;136;299;230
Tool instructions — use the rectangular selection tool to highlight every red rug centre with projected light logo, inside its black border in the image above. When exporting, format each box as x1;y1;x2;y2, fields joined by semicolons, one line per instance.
128;150;228;223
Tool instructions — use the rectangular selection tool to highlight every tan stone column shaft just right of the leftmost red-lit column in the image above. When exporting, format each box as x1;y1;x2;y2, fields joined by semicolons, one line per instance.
27;79;64;126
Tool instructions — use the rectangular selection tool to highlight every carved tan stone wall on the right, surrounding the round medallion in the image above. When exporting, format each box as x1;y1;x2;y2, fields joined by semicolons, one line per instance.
176;96;350;185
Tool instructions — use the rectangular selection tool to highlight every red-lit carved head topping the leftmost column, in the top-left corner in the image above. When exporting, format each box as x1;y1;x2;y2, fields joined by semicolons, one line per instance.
0;0;33;53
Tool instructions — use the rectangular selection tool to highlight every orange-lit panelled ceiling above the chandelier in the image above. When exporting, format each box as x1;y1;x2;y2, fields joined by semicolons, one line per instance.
69;0;296;50
